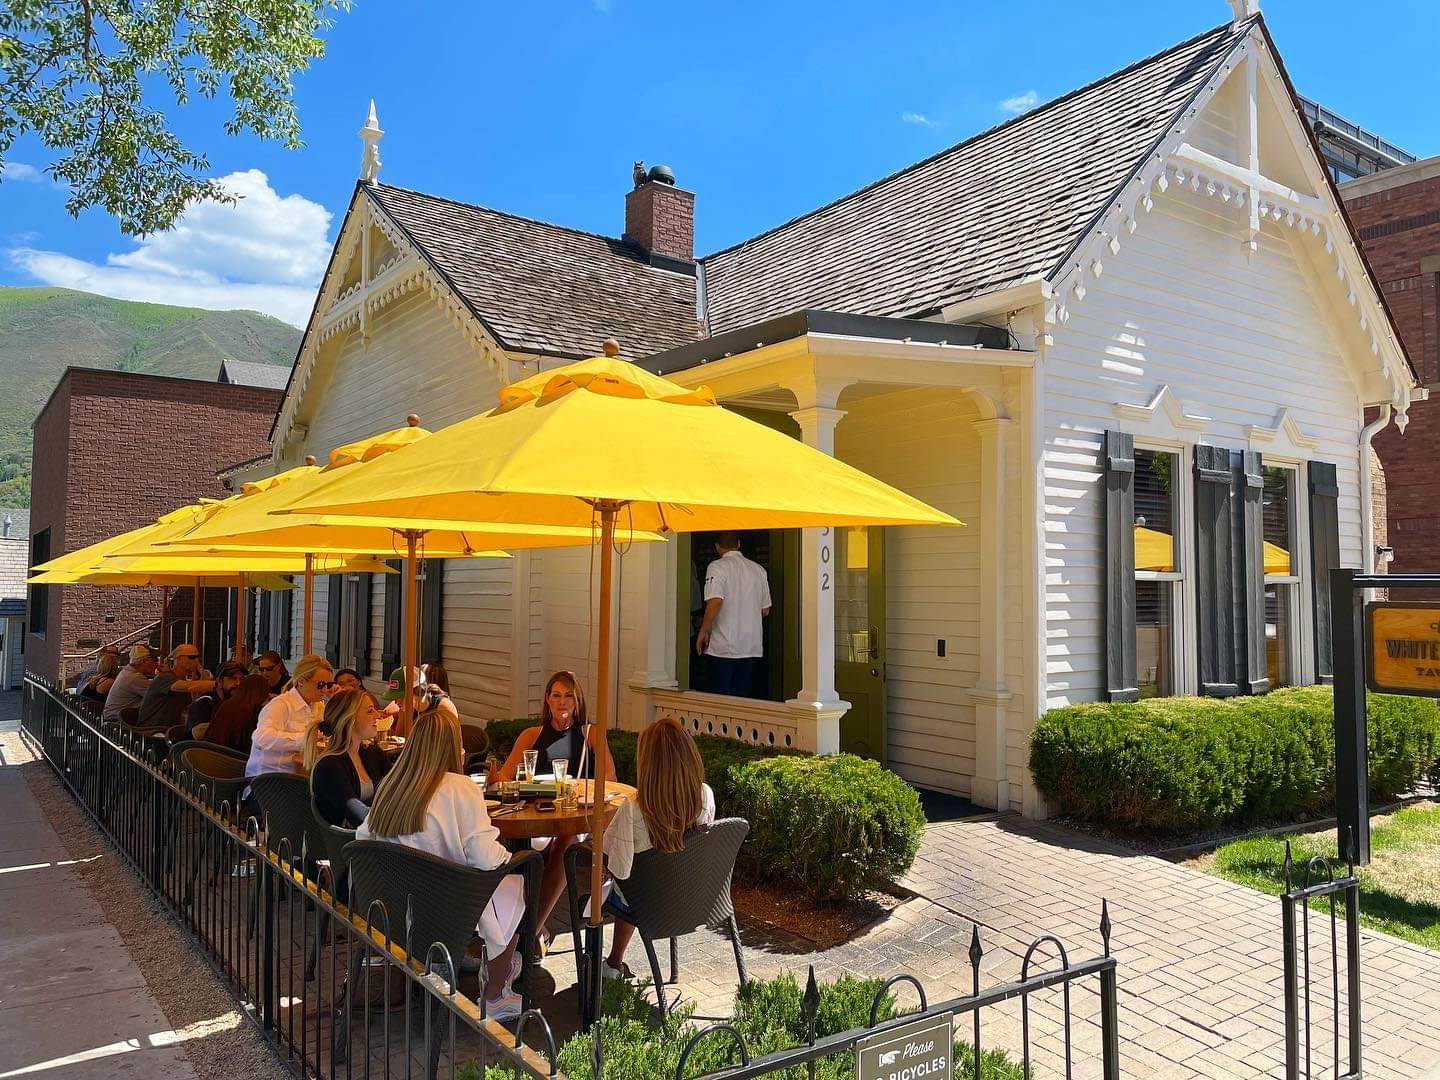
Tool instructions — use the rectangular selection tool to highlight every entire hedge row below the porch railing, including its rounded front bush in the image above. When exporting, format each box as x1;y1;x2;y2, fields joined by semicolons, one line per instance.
485;720;924;903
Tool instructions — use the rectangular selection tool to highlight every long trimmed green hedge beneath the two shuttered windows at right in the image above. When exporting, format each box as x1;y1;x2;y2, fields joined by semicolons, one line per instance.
1030;687;1440;832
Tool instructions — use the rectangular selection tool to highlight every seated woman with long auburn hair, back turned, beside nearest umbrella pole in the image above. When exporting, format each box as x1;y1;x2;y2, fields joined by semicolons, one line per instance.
603;716;716;979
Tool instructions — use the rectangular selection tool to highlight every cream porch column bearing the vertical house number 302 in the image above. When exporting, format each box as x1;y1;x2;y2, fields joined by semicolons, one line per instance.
788;403;850;753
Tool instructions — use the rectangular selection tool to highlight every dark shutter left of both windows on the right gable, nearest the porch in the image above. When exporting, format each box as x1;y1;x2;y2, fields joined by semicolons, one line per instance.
1104;431;1140;701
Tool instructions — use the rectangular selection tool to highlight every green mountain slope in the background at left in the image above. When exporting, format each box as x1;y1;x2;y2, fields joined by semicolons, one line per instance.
0;287;300;507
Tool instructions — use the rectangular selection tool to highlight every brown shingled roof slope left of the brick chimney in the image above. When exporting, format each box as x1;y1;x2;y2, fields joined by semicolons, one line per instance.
363;184;700;357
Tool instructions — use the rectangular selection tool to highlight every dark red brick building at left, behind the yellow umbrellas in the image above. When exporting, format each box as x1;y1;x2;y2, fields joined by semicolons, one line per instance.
24;367;281;677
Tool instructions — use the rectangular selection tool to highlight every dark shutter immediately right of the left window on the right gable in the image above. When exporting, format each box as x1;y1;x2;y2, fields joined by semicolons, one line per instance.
1195;445;1240;697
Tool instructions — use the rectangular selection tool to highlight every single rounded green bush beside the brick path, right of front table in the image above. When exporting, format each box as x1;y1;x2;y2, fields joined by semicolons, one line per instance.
732;753;924;903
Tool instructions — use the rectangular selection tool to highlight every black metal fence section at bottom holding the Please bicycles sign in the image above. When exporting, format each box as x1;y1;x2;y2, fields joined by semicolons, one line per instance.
675;901;1120;1080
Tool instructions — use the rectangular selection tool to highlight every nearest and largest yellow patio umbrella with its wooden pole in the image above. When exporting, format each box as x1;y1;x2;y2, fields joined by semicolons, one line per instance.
278;341;960;1002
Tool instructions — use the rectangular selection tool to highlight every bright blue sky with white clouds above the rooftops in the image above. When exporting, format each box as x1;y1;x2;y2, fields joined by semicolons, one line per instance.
0;0;1440;328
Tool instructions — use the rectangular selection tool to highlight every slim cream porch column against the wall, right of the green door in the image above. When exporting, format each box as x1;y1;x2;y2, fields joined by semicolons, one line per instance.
971;416;1012;809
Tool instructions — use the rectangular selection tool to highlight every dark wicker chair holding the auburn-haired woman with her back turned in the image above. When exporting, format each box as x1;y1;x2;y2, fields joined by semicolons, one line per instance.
564;818;750;1015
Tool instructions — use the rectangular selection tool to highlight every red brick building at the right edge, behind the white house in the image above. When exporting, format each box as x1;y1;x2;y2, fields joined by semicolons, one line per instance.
1341;157;1440;573
